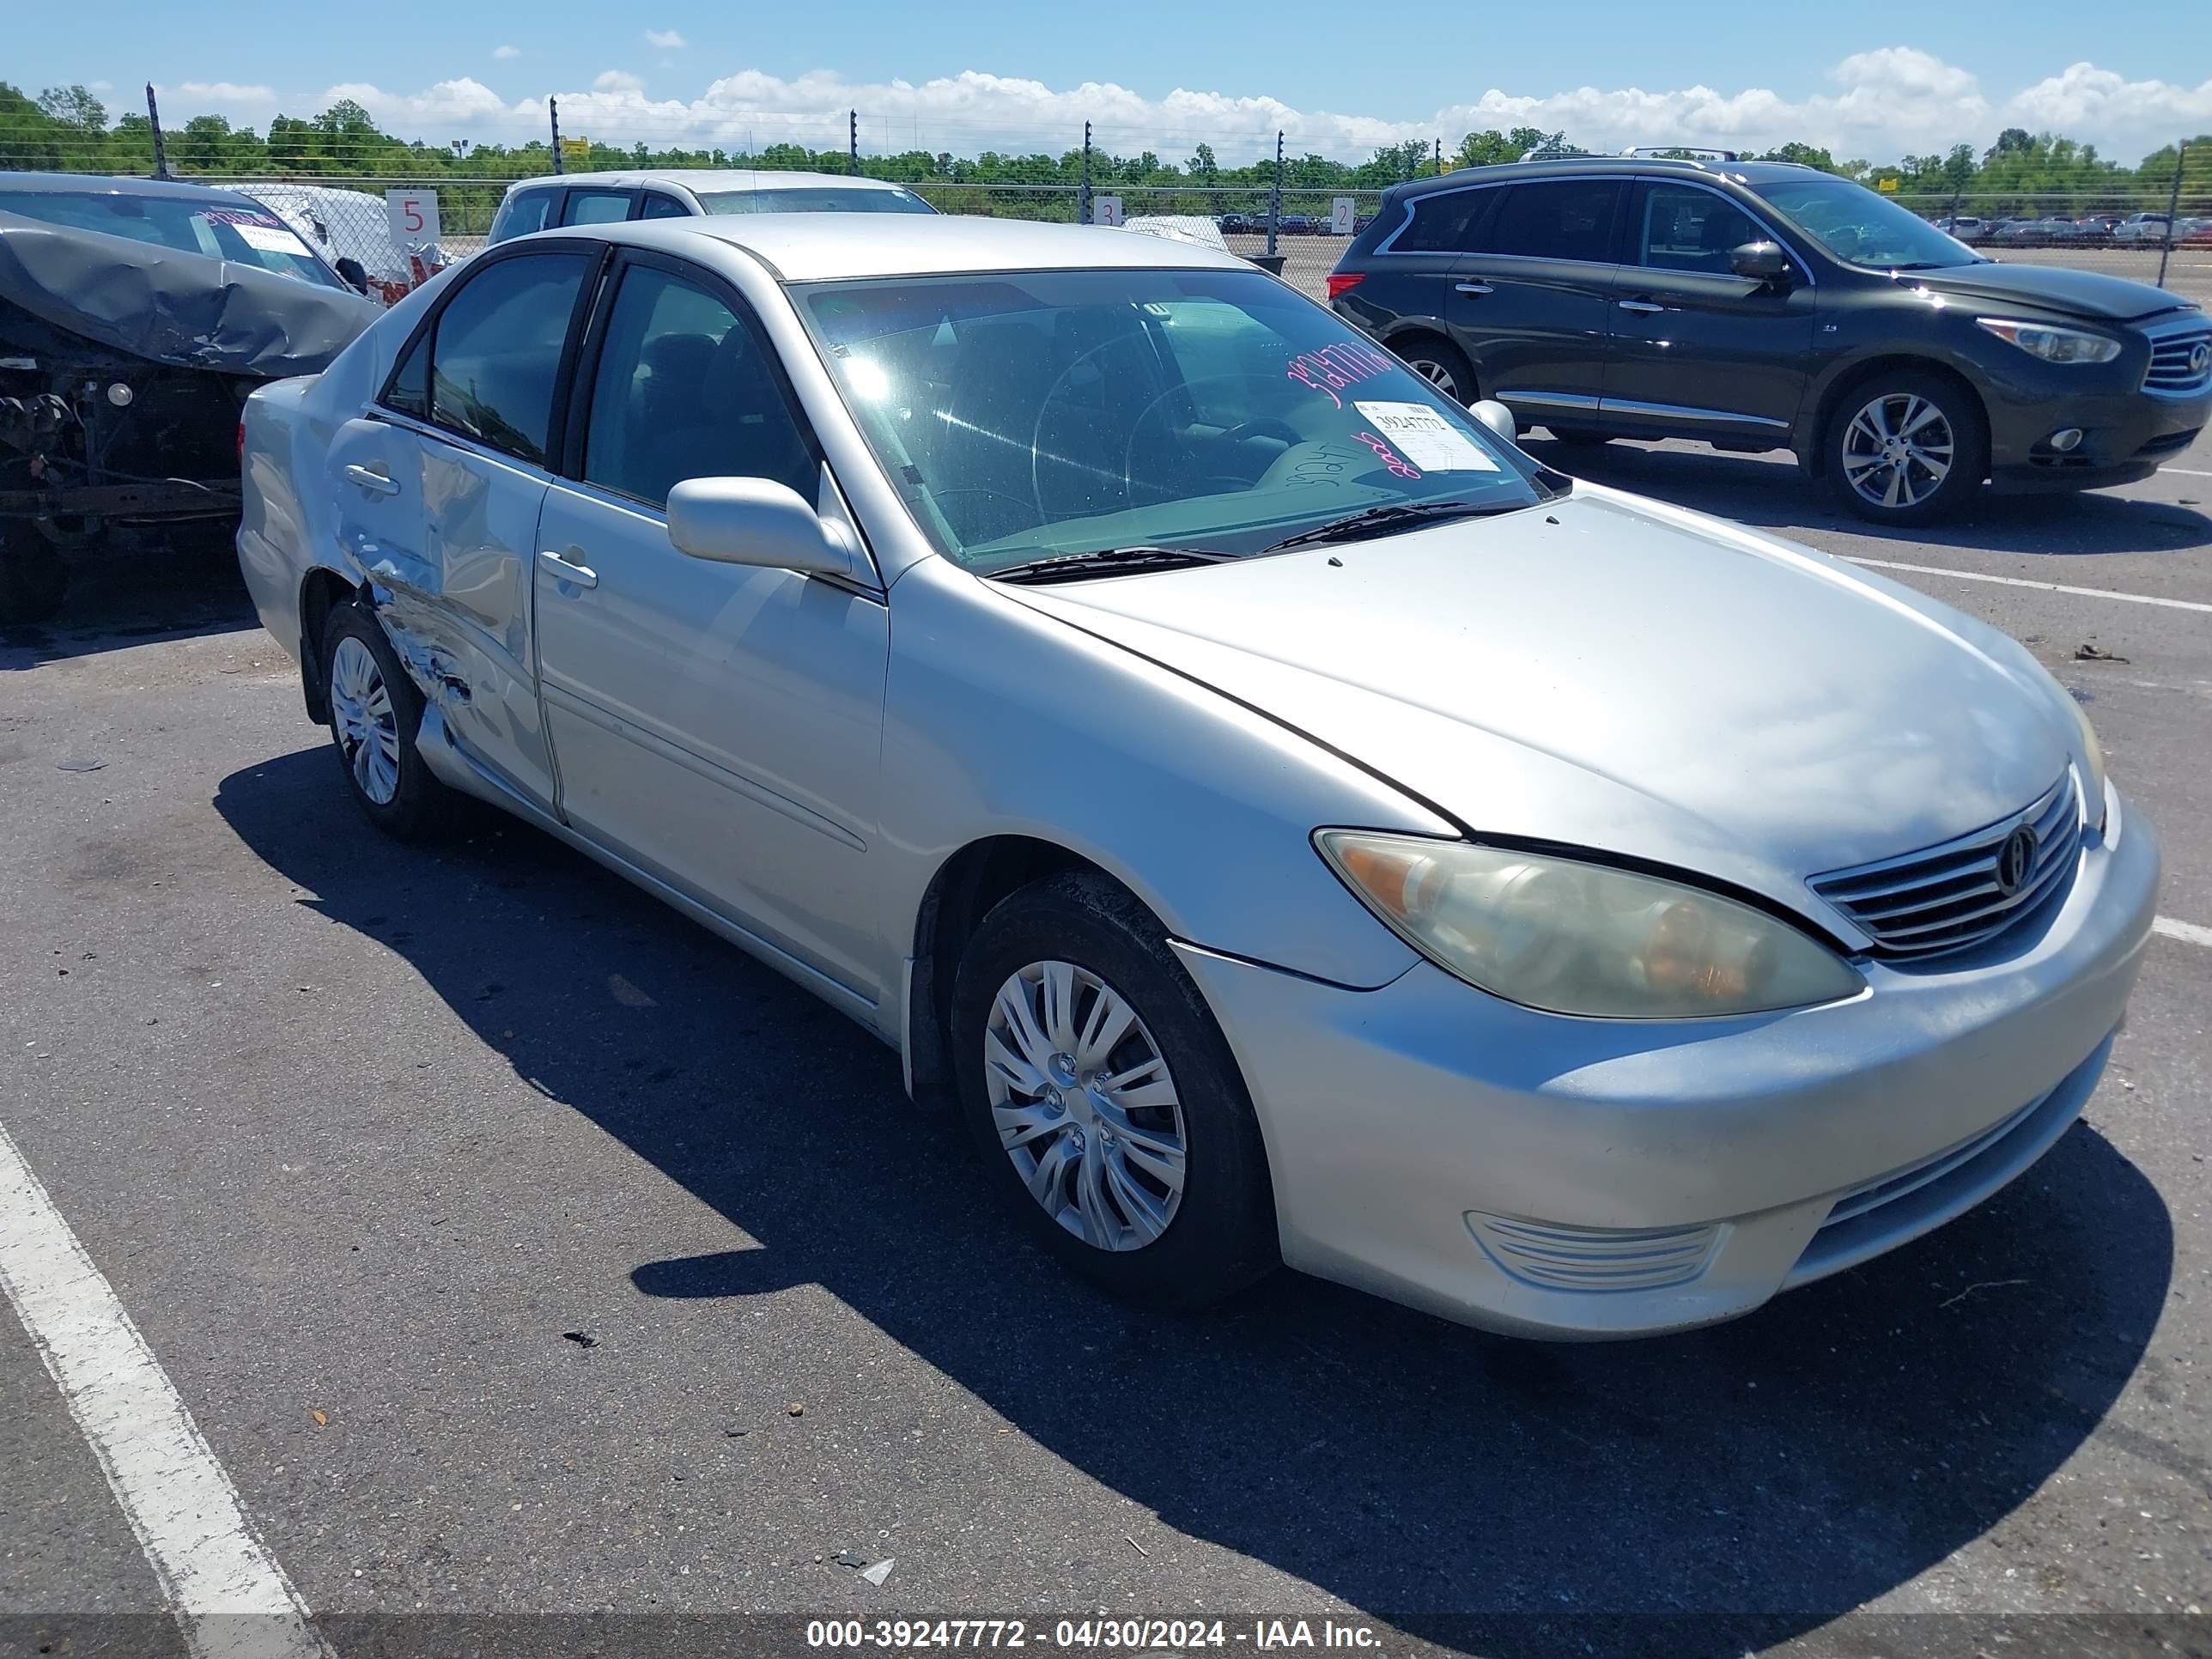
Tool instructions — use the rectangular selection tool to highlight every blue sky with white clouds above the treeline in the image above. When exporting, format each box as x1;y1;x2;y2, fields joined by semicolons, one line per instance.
17;0;2212;159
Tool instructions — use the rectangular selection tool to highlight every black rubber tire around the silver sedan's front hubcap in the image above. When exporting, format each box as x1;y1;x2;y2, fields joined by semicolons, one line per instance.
951;872;1279;1307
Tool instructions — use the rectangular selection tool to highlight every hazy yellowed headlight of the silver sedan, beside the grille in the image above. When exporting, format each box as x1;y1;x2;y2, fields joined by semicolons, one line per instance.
1314;830;1865;1020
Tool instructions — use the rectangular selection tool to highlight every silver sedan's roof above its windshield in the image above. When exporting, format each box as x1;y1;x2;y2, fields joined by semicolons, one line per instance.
542;212;1256;283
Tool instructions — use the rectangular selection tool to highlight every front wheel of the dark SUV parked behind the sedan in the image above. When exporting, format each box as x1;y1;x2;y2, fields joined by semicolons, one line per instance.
1827;374;1989;525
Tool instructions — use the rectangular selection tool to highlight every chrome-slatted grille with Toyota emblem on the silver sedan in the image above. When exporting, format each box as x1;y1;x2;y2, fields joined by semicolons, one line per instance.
1809;769;2081;957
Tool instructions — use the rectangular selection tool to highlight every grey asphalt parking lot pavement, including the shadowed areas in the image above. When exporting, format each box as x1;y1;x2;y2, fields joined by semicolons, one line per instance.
0;422;2212;1655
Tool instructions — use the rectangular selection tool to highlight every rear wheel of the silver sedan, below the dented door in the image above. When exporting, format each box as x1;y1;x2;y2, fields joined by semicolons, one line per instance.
323;604;456;841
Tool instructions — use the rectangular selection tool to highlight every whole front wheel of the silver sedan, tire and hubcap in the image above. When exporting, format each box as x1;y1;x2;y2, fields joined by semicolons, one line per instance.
951;874;1276;1307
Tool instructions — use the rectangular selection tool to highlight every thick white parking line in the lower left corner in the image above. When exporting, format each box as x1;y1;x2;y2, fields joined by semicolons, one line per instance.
0;1126;334;1659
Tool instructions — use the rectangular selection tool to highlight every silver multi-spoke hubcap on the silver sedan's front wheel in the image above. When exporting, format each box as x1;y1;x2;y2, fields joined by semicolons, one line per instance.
982;963;1186;1249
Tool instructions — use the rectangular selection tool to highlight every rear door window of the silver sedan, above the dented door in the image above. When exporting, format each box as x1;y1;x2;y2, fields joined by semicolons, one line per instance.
422;252;588;467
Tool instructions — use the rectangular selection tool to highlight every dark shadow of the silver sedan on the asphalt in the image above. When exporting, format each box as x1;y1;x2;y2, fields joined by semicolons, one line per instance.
215;745;2185;1656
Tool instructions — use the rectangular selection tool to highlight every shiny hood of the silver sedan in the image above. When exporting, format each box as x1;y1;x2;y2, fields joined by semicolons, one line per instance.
1002;484;2079;924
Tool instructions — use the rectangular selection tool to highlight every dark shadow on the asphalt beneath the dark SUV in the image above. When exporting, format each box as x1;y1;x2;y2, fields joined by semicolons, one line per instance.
1524;435;2212;556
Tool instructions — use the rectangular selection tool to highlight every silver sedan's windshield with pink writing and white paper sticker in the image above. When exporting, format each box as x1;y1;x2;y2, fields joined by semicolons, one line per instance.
794;270;1553;575
